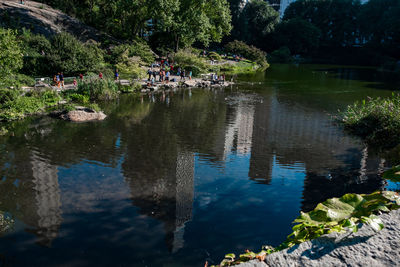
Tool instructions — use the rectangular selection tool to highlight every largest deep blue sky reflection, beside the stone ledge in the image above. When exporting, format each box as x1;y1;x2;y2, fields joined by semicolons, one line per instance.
191;153;305;262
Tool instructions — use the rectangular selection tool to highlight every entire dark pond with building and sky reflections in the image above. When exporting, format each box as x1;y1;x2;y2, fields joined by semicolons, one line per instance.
0;65;400;266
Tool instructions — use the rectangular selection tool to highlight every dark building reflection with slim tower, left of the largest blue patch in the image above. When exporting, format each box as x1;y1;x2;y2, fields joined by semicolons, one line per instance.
124;152;194;252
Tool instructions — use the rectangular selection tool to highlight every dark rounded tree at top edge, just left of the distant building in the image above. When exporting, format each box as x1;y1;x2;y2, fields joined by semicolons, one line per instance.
239;0;279;46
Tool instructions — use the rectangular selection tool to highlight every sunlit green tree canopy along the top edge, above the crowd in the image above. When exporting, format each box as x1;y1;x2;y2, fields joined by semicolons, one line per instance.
36;0;231;51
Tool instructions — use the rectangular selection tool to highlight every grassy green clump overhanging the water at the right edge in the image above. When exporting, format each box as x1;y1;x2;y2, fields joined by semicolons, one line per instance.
340;93;400;148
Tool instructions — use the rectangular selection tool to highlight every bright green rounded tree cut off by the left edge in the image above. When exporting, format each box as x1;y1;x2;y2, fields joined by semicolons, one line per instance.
0;28;22;86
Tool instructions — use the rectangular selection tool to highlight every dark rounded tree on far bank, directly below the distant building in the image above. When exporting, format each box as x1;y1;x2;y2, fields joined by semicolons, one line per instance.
274;18;321;55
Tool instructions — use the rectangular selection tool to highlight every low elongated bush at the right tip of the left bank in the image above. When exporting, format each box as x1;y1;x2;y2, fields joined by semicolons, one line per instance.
225;40;268;66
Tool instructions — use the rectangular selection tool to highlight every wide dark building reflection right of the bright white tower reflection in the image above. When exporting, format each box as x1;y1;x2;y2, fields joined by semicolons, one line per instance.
249;93;383;210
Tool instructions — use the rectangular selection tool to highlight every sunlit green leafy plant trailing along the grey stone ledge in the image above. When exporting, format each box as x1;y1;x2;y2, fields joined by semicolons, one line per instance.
219;192;400;266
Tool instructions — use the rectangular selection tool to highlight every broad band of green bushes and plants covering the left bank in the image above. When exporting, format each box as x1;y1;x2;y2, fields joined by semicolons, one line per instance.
0;28;269;127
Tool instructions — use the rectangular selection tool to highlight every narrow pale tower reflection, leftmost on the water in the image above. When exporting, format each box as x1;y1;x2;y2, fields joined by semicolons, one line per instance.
31;154;62;246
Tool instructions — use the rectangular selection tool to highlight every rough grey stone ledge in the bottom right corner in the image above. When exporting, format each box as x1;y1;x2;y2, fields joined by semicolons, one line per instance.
236;210;400;267
